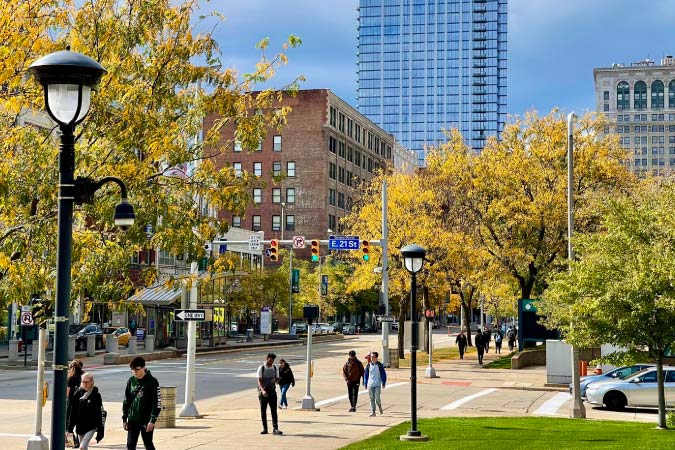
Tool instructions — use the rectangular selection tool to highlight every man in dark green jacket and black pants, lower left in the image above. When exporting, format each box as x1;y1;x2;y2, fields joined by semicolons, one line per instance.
122;356;162;450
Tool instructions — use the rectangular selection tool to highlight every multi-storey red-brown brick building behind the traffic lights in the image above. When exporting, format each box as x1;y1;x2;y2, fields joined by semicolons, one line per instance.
204;89;394;248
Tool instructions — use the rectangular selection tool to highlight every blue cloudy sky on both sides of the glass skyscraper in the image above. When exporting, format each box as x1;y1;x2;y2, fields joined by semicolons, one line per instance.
197;0;675;116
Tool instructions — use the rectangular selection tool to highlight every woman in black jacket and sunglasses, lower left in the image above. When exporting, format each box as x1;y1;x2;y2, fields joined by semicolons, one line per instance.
68;373;103;450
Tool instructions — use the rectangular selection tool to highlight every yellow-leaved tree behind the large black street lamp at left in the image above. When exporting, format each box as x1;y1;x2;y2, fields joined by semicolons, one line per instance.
0;0;300;307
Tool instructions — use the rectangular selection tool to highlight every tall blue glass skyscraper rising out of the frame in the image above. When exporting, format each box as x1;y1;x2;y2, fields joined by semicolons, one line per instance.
357;0;507;165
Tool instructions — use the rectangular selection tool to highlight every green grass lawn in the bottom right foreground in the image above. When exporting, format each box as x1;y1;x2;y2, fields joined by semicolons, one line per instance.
342;417;675;450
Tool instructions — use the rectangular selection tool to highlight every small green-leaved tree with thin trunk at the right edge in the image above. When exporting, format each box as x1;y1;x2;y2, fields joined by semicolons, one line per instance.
540;180;675;428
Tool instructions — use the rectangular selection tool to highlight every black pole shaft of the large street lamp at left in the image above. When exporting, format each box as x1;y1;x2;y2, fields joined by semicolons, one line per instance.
51;125;75;450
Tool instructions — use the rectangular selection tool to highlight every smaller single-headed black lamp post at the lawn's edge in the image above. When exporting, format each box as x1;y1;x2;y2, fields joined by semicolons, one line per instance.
400;244;429;441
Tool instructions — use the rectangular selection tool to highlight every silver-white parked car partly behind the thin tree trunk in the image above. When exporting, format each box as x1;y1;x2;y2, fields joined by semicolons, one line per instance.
586;366;675;410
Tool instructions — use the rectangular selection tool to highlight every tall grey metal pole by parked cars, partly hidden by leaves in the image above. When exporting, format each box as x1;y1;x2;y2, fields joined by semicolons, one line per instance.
567;112;586;418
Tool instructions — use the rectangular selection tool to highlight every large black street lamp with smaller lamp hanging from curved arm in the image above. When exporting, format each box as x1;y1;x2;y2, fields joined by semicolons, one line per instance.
28;48;135;449
